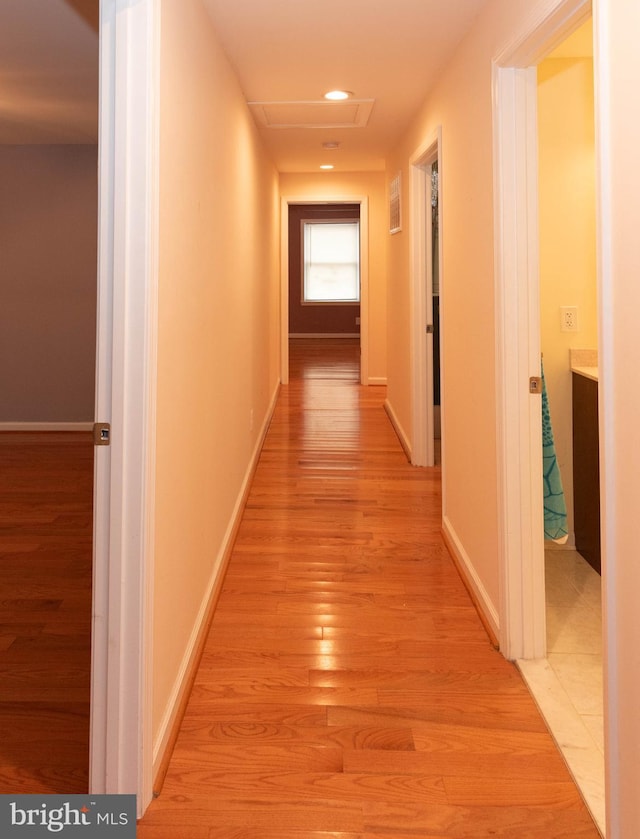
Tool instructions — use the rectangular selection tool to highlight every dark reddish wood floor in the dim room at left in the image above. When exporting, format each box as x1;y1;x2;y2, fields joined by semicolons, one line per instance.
0;432;93;794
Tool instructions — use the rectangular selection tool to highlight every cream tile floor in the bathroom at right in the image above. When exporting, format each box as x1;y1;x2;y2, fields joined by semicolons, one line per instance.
518;550;605;836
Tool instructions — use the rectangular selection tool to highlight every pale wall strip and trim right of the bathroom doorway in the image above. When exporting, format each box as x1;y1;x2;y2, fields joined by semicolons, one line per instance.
594;0;640;839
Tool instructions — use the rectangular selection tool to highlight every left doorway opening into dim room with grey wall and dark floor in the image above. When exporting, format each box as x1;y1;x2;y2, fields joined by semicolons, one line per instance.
0;0;99;794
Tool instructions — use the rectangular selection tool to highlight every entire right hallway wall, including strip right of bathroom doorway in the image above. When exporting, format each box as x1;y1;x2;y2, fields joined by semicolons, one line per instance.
388;0;640;839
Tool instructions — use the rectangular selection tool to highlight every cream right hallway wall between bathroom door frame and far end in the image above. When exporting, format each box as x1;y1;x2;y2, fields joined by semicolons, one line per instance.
387;0;531;614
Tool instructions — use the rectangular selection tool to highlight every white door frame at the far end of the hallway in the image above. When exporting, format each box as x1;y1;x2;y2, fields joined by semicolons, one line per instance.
280;194;369;385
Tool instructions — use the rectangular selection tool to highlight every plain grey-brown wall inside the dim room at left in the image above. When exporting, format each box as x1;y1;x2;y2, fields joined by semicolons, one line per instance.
0;145;98;423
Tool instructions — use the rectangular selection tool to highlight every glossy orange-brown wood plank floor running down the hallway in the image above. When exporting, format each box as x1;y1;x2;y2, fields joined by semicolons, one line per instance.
138;341;599;839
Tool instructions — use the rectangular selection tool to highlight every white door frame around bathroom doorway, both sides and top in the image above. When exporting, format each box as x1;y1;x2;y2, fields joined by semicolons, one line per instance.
493;0;635;839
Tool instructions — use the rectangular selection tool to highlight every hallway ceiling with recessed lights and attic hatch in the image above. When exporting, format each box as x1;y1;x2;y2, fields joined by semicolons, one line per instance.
203;0;486;172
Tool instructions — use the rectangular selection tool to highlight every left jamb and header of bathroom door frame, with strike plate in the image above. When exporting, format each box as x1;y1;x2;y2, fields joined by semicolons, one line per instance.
493;0;591;659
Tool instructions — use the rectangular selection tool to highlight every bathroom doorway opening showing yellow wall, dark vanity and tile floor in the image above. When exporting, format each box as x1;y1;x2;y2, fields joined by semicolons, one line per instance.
536;13;604;829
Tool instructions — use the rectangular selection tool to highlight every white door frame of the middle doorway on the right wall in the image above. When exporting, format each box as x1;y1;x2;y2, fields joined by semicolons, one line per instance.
409;126;442;466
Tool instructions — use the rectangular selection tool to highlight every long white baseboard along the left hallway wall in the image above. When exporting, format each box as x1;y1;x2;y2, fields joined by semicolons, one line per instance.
153;383;280;779
